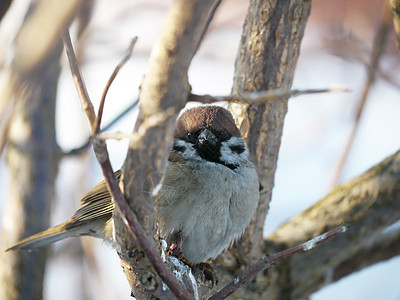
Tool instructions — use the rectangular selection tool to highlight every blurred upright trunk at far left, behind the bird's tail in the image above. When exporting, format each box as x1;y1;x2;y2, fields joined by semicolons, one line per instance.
0;43;62;300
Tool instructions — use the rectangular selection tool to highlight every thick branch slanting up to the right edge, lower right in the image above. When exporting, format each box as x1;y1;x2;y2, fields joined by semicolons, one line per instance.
268;151;400;298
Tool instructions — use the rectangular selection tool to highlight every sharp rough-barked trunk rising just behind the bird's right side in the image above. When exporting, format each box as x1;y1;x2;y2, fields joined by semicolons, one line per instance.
230;0;311;270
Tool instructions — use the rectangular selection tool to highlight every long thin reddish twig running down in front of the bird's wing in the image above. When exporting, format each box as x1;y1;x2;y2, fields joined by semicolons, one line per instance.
63;29;193;299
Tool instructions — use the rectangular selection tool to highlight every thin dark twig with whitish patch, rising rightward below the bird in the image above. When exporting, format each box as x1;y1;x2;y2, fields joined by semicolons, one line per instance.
209;224;348;300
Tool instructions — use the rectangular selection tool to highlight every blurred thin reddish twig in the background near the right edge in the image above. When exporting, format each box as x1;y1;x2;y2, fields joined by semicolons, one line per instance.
332;3;391;186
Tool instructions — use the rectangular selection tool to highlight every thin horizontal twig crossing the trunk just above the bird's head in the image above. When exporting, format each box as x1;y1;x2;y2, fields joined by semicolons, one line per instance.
189;87;350;104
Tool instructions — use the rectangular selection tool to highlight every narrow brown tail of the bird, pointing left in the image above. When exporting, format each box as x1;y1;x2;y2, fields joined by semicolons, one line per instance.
6;223;73;251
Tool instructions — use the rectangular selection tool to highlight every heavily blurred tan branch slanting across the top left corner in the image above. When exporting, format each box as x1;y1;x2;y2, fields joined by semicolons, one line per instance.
0;0;82;155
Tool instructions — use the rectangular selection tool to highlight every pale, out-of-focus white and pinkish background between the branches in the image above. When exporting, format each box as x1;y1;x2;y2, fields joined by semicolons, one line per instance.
0;0;400;300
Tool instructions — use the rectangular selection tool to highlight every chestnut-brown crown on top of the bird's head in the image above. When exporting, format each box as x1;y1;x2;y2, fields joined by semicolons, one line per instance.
175;105;241;138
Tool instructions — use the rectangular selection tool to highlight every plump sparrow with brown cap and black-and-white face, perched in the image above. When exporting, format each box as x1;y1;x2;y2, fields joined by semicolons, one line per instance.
6;105;259;264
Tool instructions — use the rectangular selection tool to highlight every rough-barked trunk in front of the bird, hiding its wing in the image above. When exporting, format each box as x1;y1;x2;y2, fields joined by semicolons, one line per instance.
114;0;220;299
